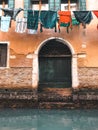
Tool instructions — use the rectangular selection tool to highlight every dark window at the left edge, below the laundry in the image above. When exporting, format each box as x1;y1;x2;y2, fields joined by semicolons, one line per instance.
0;43;8;67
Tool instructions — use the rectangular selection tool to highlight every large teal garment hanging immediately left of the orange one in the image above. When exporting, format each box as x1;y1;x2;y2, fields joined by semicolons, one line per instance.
40;11;57;32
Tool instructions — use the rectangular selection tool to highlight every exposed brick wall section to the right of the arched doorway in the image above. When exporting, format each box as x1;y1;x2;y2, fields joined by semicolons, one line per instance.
78;67;98;88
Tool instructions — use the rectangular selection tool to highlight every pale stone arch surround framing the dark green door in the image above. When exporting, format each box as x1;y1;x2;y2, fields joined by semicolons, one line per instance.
32;37;79;88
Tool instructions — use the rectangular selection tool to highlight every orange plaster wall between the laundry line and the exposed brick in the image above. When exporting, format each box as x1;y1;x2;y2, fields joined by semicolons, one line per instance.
0;1;98;67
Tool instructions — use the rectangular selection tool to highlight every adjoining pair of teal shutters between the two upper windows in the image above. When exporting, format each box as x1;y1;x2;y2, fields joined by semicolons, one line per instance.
48;0;61;11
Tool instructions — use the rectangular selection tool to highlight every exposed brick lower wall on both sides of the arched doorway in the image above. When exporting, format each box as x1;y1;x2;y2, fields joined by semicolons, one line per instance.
0;67;98;88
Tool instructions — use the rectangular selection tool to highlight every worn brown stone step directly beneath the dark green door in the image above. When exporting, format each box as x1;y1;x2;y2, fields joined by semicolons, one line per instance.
38;88;72;102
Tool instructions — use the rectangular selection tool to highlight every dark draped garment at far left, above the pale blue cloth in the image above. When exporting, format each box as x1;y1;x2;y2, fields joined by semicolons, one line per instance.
0;8;23;20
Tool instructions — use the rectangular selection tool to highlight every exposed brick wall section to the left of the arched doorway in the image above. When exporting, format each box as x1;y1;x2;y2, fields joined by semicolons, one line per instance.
0;68;32;88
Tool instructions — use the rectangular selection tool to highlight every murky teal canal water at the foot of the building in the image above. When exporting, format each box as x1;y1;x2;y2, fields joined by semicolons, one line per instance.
0;109;98;130
